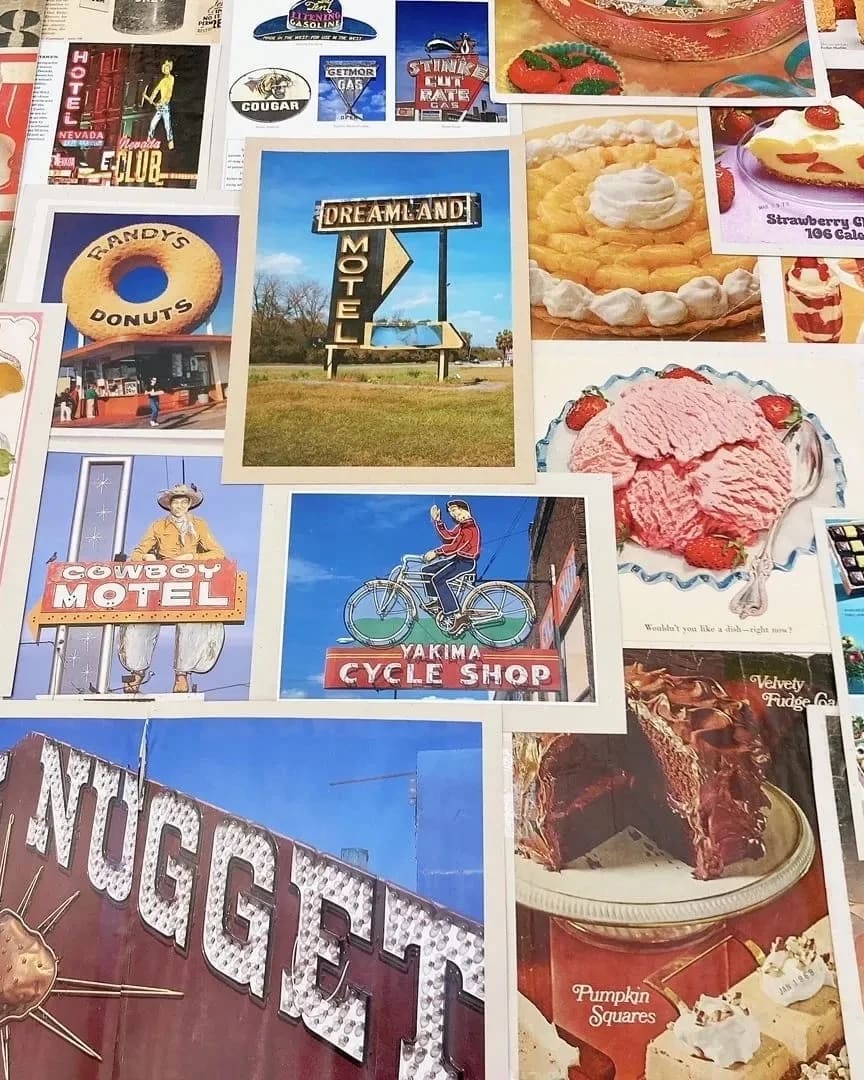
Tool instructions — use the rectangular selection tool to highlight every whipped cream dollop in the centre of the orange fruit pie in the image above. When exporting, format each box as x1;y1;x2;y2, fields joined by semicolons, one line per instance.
588;165;693;232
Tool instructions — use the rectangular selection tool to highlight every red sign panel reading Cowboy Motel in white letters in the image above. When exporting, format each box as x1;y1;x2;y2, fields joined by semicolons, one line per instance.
36;558;246;626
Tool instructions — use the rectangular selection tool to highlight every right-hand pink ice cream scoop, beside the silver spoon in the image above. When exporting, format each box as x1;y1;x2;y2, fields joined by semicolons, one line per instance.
688;433;792;540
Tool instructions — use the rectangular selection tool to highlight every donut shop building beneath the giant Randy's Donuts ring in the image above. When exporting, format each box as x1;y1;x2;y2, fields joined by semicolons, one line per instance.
57;334;231;421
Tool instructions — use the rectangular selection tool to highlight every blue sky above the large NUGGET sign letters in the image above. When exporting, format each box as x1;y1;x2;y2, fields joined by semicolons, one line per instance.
0;718;483;918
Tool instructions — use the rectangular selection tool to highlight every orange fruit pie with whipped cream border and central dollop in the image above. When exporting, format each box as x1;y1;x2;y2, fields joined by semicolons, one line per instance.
527;117;761;337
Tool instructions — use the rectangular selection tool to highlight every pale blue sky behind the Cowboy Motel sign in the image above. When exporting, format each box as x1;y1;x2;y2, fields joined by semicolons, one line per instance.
13;453;261;700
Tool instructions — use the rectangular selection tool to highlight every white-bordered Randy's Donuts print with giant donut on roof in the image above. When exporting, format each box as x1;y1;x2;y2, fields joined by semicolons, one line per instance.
5;188;238;438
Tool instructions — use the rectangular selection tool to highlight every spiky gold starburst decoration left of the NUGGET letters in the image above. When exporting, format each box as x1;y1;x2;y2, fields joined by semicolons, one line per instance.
0;814;183;1080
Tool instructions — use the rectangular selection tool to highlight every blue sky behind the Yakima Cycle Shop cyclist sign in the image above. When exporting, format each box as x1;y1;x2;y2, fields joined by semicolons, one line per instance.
282;491;537;700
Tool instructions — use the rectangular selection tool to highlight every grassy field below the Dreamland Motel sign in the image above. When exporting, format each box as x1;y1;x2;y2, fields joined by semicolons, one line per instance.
243;364;513;468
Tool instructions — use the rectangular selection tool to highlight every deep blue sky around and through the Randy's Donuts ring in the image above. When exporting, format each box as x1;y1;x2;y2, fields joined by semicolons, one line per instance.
42;212;238;349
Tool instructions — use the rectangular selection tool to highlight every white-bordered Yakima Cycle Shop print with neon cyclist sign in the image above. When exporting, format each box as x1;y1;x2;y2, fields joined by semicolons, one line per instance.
276;476;623;731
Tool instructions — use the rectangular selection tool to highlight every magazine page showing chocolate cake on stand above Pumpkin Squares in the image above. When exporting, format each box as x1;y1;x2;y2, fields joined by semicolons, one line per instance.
504;673;855;1080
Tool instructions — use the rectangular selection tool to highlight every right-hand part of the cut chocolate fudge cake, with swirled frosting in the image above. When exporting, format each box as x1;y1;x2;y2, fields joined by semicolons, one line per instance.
624;663;769;880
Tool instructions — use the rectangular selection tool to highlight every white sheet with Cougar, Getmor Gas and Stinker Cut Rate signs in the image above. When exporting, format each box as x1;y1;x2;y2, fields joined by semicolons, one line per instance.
214;0;510;190
